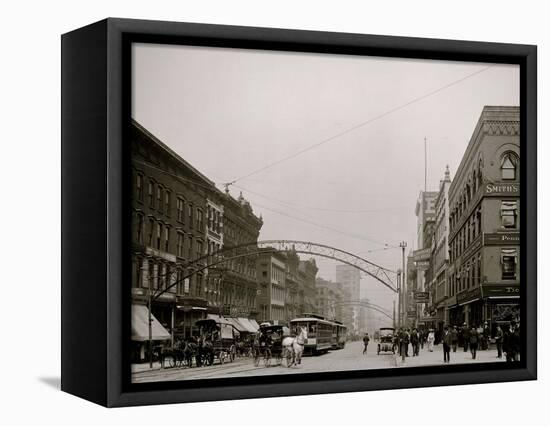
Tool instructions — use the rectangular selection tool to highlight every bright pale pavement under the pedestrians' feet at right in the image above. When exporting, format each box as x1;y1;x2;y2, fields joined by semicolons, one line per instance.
395;344;506;367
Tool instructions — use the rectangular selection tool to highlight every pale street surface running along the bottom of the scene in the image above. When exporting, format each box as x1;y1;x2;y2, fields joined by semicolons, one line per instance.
132;342;503;383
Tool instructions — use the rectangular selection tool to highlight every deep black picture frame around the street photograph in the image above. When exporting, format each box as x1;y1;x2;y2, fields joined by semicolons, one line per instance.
61;18;537;407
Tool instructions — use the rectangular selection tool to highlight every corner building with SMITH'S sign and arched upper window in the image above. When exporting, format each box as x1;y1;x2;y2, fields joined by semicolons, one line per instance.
447;106;521;330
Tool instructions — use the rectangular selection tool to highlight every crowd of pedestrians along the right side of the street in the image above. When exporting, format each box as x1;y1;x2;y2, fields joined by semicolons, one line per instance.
384;321;521;364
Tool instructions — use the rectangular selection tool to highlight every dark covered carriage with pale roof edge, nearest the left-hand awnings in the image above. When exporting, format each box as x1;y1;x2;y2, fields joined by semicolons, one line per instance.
195;317;239;366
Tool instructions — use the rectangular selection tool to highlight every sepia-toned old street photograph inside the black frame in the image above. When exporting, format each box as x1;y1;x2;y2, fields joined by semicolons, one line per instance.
126;42;525;383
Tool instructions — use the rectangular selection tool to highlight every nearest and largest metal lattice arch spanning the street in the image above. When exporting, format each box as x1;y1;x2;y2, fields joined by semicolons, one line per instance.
154;240;398;298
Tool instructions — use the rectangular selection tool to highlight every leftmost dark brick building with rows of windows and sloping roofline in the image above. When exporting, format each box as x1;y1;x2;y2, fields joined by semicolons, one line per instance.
131;122;215;352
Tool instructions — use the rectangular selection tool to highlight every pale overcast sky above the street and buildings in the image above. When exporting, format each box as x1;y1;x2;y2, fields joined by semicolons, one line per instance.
132;44;519;309
